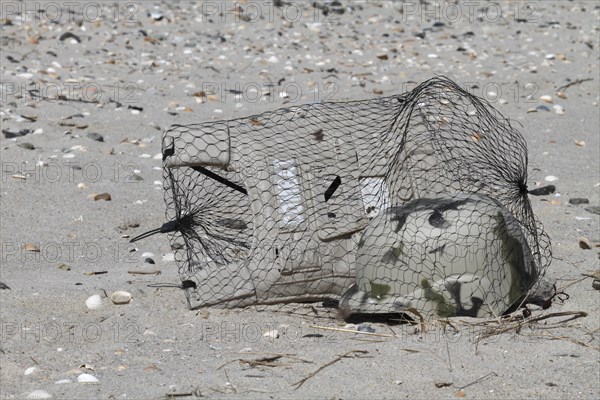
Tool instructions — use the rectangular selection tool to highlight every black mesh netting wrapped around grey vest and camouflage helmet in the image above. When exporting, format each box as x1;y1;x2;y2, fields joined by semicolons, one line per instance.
134;77;550;316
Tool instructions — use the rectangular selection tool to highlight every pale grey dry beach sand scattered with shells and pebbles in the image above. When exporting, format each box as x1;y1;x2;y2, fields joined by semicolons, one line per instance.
0;0;600;399
